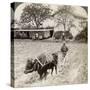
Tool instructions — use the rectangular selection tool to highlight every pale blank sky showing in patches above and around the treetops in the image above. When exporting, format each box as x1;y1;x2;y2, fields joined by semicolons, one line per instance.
15;3;87;20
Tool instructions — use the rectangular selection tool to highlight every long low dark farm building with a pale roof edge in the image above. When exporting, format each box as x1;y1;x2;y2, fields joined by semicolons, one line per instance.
11;28;54;40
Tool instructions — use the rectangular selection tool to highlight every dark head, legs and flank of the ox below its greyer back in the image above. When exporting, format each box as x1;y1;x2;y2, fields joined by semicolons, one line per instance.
24;53;58;79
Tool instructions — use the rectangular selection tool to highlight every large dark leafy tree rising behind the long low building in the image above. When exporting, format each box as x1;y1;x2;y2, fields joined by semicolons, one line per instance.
21;4;51;28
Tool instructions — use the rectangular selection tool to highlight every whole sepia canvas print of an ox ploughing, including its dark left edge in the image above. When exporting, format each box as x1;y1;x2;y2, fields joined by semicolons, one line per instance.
10;2;88;87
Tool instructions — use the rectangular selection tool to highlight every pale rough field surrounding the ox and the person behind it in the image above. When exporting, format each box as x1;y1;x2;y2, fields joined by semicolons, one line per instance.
11;39;88;87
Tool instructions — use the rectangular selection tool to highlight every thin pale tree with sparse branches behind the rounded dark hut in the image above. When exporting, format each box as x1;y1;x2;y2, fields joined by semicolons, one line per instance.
53;6;74;31
